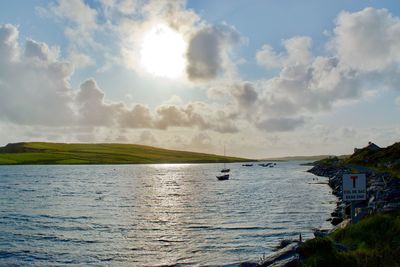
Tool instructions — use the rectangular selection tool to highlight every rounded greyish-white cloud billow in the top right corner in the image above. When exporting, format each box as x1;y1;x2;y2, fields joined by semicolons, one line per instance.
330;8;400;71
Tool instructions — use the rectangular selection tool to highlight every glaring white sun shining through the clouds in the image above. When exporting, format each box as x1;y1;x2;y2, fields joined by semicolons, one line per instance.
140;24;187;79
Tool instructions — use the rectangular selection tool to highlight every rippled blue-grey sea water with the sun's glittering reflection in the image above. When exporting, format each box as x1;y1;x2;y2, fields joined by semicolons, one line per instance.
0;161;336;266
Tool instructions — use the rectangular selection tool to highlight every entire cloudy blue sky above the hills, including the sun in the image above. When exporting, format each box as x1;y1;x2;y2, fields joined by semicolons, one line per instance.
0;0;400;159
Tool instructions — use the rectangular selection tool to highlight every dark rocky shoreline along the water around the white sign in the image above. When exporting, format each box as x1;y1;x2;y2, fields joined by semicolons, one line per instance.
239;161;400;267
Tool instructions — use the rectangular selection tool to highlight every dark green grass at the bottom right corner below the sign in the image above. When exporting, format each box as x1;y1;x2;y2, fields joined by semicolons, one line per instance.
299;213;400;267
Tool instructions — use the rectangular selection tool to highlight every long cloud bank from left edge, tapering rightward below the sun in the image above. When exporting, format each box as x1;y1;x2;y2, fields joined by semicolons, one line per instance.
0;22;237;134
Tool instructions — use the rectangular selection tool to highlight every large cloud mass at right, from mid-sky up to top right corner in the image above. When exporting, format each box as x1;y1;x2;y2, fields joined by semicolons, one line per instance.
252;8;400;134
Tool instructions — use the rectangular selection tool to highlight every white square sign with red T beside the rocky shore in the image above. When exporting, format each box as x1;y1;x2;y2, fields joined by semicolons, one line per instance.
343;174;366;201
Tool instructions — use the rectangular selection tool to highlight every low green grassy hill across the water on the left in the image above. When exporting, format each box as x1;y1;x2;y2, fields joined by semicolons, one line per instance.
0;142;250;165
